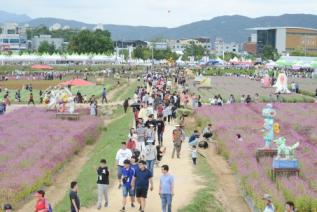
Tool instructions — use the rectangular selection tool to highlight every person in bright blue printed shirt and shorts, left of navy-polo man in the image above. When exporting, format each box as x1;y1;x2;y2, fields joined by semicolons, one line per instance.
120;160;135;212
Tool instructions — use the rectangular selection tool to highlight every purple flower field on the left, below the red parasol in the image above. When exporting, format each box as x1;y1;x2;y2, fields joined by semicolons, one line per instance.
0;107;102;205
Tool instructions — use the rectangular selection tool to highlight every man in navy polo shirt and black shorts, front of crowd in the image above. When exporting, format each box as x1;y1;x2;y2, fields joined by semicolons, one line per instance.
132;160;153;212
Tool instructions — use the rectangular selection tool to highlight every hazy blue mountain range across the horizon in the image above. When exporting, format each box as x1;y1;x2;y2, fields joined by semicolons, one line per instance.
0;11;317;42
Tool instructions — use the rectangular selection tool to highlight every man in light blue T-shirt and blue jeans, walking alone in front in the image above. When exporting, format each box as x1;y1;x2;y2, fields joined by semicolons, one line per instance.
159;165;174;212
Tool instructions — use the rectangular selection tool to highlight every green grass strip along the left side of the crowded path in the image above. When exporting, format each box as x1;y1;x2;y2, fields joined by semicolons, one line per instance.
54;112;132;212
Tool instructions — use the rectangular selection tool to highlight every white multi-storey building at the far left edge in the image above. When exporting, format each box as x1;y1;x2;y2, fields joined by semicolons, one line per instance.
0;23;28;52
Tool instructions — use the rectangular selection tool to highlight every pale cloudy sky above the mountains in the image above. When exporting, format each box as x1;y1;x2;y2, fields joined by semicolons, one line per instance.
0;0;317;27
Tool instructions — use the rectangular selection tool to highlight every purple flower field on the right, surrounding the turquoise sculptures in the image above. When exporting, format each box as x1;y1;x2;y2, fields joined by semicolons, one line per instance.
197;103;317;211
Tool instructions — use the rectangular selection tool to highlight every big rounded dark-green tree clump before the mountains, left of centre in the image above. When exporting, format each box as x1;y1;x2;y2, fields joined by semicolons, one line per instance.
68;30;114;53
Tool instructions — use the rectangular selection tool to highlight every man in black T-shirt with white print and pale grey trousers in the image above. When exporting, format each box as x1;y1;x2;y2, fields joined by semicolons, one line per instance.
97;159;109;210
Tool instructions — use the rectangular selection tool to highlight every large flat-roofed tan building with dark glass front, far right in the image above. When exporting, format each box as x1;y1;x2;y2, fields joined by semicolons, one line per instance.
249;27;317;55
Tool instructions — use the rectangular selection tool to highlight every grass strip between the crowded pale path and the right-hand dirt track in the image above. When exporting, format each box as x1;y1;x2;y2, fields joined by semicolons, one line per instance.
179;156;224;212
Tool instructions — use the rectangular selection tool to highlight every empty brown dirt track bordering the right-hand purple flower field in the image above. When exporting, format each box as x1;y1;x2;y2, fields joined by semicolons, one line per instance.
200;144;251;212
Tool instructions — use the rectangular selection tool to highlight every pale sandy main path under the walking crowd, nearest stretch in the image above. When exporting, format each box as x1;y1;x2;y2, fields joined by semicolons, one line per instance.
81;123;201;212
